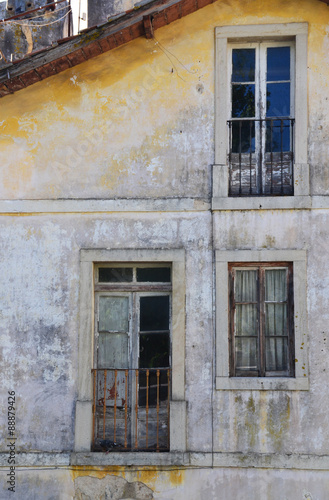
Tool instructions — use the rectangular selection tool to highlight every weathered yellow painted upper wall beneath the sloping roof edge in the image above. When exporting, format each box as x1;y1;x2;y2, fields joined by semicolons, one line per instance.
0;0;329;199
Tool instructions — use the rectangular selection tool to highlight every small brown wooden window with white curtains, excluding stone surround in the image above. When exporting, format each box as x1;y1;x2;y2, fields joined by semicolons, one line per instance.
229;263;294;377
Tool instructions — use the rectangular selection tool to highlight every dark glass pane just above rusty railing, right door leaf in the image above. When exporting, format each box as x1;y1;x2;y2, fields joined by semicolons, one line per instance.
139;333;170;368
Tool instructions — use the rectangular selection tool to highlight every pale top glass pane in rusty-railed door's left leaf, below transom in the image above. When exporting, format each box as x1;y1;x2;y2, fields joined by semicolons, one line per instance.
98;296;129;332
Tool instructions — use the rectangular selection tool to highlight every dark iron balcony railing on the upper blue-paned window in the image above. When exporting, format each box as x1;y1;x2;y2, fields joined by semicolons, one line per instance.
227;117;295;196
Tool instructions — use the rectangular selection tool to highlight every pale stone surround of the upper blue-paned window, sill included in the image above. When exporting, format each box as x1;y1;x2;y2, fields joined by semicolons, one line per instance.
212;23;310;210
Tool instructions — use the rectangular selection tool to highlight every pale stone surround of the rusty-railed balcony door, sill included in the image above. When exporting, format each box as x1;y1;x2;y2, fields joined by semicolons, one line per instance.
71;249;186;465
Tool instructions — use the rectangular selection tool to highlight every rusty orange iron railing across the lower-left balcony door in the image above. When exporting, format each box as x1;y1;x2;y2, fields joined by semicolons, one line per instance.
92;368;170;452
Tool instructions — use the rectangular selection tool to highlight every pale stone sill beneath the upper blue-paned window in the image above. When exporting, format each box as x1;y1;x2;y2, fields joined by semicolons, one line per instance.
212;196;311;210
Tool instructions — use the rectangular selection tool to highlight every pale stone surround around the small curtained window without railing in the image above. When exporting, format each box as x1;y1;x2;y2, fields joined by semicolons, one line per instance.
216;250;309;391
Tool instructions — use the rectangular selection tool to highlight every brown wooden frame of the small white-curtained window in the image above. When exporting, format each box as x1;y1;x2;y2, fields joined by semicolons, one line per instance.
228;262;295;377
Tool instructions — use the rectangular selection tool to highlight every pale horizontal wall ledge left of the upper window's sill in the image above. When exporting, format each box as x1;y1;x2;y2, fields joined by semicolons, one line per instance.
0;198;210;215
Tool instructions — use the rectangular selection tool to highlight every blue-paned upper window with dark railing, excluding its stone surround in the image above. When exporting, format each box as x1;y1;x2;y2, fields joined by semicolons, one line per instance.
228;42;295;196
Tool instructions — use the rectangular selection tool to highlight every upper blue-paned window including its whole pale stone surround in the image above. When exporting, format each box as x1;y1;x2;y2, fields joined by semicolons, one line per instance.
212;23;310;210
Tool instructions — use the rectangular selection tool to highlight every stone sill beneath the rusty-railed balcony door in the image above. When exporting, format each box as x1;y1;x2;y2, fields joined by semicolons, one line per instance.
71;451;185;466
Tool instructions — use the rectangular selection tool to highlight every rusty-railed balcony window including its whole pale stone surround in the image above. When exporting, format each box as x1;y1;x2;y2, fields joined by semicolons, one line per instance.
72;248;186;465
